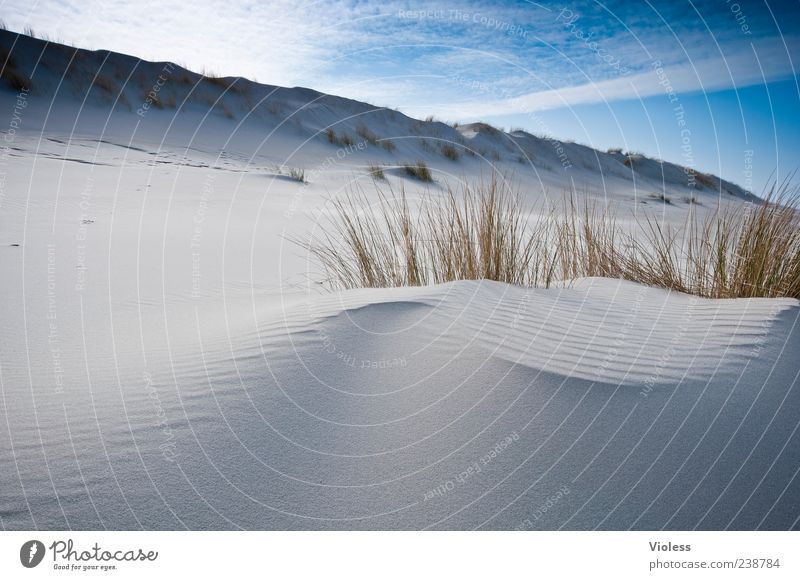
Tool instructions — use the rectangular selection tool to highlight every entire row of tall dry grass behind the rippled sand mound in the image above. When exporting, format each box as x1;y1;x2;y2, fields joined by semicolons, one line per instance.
302;177;800;298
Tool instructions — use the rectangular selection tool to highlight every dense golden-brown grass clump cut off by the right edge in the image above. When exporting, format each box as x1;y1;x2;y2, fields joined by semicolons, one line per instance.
620;183;800;298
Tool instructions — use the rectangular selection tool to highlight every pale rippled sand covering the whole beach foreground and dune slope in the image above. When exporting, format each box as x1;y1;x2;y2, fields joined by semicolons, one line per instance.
0;32;800;529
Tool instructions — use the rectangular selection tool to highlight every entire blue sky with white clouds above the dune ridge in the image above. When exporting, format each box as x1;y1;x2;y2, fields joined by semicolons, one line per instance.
0;0;800;192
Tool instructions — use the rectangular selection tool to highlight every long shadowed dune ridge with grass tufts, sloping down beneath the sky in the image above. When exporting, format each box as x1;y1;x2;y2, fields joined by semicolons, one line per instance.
0;31;748;204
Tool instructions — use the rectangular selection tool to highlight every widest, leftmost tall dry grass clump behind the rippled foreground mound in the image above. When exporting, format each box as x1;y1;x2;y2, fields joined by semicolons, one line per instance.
305;174;552;288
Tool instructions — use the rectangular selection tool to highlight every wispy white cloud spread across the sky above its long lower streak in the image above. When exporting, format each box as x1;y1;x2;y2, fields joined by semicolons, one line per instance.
3;0;799;118
